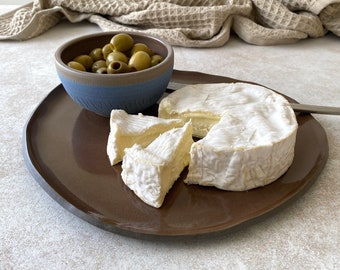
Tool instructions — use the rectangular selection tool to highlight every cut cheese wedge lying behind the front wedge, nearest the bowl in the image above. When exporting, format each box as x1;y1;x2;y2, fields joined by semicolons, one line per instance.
106;110;184;165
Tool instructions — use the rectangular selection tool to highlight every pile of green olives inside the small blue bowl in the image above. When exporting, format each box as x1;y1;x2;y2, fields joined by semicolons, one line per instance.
67;33;163;74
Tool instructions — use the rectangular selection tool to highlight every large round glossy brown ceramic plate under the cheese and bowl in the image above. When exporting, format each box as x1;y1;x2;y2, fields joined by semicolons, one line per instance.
24;71;328;238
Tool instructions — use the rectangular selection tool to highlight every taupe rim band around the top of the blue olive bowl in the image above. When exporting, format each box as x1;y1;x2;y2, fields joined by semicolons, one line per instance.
55;31;174;85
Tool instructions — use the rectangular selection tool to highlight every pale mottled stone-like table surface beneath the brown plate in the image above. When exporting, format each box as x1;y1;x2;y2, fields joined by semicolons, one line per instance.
0;5;340;269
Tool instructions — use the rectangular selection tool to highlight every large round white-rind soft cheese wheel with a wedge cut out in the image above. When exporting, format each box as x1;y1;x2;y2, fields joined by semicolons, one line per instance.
159;83;298;191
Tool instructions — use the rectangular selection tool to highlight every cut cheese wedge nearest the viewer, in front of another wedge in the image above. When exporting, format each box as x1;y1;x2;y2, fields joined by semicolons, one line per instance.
121;122;193;208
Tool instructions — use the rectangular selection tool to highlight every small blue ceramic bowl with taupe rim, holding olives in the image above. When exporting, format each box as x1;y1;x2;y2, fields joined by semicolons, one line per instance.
55;31;174;117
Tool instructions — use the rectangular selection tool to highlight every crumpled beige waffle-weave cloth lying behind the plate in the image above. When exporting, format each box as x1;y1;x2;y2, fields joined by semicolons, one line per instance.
0;0;340;47
